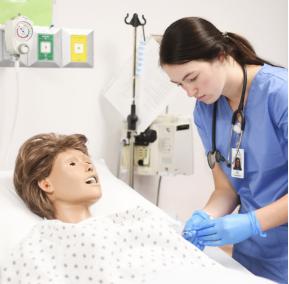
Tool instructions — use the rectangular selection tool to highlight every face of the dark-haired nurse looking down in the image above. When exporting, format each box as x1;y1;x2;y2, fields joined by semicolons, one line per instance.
163;59;226;104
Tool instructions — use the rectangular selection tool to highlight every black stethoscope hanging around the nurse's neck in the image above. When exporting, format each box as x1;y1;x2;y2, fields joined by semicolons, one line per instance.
207;66;247;169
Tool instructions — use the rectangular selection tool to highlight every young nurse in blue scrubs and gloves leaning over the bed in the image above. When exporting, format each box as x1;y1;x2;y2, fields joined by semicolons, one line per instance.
160;17;288;283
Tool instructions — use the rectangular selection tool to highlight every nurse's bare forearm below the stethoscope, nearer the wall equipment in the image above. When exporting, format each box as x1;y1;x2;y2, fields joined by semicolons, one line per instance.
203;164;239;218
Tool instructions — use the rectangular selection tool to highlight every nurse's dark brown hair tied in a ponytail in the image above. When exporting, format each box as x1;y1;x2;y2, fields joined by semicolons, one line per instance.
160;17;272;66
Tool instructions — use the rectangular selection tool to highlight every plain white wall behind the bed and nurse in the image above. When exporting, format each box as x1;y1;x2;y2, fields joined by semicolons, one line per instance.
0;0;288;220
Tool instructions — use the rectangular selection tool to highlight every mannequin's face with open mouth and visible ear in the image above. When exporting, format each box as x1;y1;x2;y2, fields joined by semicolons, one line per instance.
38;149;101;206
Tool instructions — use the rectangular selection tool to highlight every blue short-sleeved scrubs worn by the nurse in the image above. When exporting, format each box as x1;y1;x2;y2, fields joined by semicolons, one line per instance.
194;64;288;283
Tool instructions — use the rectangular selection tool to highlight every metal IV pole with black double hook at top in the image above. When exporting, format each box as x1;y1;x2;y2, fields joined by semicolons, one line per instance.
124;13;146;187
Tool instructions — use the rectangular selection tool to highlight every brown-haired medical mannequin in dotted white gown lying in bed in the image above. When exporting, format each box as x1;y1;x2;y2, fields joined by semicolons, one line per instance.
5;133;230;284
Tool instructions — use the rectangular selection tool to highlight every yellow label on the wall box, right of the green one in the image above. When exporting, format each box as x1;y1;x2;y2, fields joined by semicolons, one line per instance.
70;35;87;62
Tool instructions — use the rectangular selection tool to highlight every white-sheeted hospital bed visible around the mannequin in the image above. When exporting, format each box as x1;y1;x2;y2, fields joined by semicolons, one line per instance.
0;160;272;283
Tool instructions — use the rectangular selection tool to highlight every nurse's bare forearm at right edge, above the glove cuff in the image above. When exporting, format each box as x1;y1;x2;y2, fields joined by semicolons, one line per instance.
256;194;288;231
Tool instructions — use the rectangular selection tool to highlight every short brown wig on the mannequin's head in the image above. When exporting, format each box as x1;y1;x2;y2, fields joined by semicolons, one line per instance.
13;133;88;219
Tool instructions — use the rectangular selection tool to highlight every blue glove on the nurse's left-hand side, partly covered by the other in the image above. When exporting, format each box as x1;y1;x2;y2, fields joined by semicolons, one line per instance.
183;210;210;250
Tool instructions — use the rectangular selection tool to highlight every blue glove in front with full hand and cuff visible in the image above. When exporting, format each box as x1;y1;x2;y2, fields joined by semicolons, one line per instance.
197;211;266;246
